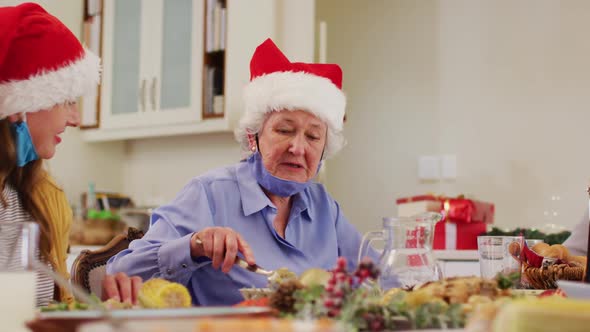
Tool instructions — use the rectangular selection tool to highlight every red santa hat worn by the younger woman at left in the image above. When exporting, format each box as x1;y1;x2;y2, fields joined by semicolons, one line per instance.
0;3;100;119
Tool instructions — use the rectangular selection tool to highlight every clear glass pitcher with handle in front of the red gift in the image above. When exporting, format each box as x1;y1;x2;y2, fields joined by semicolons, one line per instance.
359;212;442;290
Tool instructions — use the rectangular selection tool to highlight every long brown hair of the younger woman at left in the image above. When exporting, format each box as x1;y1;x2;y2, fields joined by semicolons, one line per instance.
0;119;56;267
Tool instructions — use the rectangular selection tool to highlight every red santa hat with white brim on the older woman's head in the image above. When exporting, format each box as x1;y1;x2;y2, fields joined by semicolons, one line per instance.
236;38;346;156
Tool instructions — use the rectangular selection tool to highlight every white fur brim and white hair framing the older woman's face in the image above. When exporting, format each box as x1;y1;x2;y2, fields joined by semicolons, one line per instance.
234;71;346;159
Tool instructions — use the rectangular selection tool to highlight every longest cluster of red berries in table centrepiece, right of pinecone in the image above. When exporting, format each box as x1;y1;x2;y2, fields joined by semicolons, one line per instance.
323;257;353;317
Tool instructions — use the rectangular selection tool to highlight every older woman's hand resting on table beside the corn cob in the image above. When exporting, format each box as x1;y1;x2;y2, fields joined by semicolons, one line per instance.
102;272;142;304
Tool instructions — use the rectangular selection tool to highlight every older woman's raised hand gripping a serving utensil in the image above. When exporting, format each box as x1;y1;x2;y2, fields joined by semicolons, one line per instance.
191;227;256;273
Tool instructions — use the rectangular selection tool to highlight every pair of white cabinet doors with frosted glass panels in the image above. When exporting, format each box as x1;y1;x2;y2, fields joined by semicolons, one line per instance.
100;0;203;129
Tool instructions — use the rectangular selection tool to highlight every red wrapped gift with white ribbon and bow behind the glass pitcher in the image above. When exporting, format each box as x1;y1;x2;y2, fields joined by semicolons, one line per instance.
397;195;494;250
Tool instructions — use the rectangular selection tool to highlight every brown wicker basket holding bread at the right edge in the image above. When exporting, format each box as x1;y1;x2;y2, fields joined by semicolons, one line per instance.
522;262;585;289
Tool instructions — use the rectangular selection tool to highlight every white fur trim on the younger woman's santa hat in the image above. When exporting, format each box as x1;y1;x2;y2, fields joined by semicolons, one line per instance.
0;50;100;119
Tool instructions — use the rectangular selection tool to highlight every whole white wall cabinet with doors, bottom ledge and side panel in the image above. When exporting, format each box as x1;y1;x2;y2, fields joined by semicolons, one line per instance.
83;0;286;141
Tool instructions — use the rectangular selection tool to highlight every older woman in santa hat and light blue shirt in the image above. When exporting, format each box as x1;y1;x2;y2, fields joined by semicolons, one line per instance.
107;39;384;305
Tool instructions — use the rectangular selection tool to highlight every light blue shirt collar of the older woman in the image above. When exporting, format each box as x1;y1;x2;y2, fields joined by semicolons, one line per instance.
236;162;312;221
